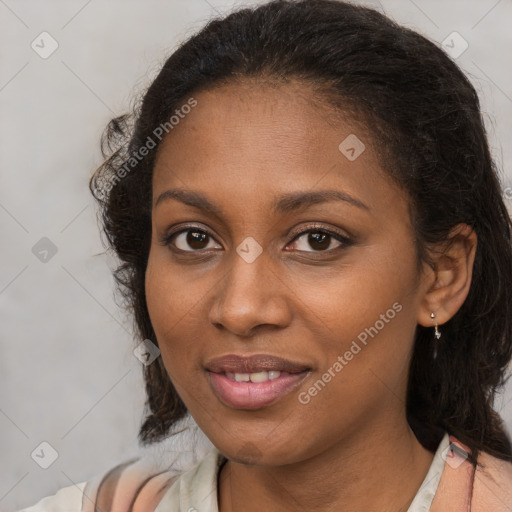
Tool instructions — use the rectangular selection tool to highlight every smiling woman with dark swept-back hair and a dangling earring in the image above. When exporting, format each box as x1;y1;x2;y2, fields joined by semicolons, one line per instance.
22;0;512;512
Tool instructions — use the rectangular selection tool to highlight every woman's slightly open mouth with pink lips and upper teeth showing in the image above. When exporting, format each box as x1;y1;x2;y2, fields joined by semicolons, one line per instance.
206;354;311;410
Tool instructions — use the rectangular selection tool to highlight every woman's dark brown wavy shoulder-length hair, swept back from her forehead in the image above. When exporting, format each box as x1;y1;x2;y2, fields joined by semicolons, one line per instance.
89;0;512;464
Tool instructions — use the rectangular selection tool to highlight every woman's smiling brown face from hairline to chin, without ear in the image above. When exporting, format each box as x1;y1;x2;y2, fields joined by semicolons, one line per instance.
146;79;425;465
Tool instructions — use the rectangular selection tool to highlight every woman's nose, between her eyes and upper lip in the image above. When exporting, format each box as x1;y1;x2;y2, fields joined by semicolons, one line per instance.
209;246;292;337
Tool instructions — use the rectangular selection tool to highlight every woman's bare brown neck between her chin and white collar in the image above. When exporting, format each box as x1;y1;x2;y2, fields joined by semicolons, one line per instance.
218;422;433;512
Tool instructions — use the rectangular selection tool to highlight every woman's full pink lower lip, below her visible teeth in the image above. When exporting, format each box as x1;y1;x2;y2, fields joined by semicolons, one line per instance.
208;371;309;409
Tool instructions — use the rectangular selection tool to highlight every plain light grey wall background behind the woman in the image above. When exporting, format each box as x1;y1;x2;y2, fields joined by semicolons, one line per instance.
0;0;512;512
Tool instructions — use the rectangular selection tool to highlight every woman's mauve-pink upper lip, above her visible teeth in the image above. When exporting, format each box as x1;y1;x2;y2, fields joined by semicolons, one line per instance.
205;354;310;373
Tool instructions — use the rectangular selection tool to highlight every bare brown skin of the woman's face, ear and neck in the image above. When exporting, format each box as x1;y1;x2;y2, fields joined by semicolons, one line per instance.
146;82;476;512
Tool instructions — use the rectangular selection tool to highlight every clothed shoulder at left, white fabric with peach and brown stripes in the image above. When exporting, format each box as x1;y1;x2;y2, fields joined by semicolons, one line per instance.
20;458;180;512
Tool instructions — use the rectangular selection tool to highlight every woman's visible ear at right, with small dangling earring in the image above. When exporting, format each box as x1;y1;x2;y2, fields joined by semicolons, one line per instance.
417;224;477;327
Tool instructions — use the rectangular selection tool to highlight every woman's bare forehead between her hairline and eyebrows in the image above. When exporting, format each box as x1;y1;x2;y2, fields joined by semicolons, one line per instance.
153;82;404;217
